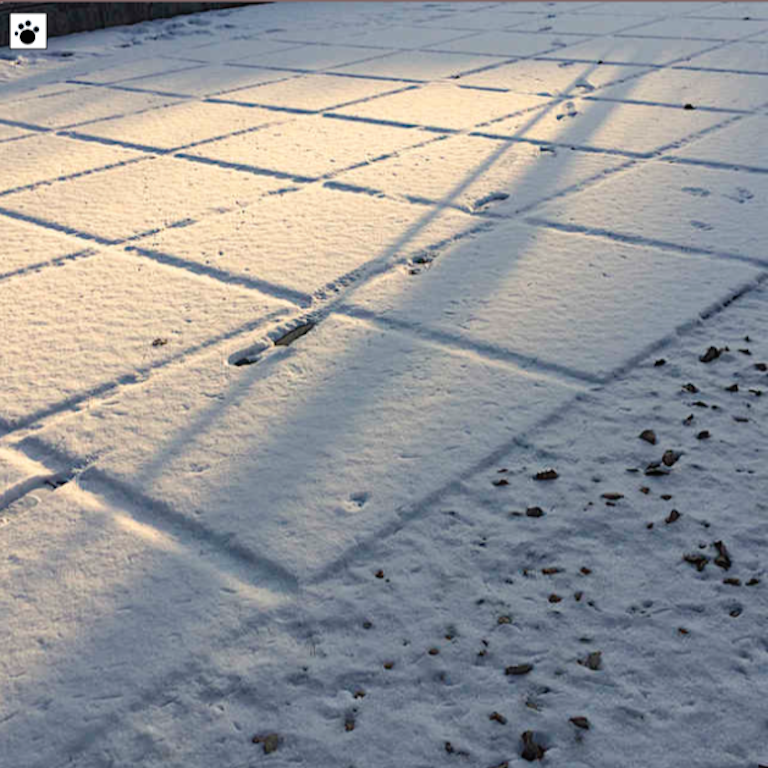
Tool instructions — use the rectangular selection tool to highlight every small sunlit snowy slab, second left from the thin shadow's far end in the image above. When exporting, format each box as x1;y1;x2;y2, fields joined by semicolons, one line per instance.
210;74;414;112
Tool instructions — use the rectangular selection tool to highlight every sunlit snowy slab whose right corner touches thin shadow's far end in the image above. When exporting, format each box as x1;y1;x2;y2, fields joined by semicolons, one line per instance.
335;83;548;130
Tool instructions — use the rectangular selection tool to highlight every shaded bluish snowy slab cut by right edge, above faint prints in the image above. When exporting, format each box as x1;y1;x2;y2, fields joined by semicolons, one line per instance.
669;115;768;170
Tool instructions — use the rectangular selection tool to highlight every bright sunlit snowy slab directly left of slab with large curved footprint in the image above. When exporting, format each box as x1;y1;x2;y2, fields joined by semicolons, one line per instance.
185;112;434;178
